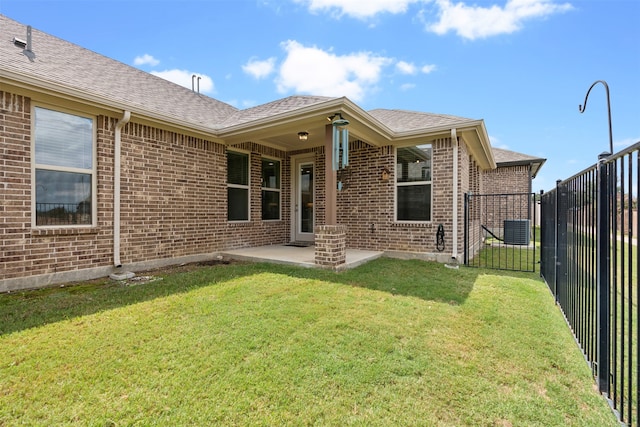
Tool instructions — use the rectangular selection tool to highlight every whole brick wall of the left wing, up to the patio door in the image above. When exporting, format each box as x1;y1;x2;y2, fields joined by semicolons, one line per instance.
0;92;291;291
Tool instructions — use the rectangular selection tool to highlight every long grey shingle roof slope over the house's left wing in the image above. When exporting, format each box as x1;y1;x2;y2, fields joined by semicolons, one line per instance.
0;15;238;129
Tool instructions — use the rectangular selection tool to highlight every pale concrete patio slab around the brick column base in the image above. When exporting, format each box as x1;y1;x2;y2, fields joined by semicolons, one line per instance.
220;245;383;270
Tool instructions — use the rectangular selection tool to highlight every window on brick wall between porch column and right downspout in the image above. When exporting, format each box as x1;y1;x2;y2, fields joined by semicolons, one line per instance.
396;145;431;222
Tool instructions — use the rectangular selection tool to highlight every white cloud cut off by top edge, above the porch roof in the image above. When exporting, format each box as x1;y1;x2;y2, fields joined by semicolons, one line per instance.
295;0;419;19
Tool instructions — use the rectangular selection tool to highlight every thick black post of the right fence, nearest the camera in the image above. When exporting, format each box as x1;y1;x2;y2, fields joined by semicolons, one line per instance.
596;153;611;396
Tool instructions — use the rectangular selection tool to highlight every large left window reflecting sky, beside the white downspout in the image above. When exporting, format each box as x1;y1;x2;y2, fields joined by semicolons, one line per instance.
34;107;95;226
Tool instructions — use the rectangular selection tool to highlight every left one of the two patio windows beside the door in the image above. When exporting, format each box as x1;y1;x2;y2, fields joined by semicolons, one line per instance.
227;151;249;221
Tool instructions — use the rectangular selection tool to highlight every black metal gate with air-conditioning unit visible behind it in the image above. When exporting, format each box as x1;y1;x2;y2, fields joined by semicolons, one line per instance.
464;193;539;271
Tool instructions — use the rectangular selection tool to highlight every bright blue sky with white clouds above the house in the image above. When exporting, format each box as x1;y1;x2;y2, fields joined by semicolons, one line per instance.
0;0;640;191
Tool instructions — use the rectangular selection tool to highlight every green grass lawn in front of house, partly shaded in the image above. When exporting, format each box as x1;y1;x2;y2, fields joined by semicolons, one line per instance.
0;259;619;427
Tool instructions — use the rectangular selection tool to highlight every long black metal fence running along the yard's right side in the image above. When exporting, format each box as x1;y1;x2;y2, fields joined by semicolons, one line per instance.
540;142;640;426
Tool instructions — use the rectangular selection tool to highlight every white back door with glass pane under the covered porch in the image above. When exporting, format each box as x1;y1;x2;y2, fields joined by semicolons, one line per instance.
292;157;315;242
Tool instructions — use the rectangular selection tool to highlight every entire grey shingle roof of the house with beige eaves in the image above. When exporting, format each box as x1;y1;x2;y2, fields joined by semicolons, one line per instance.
0;15;495;169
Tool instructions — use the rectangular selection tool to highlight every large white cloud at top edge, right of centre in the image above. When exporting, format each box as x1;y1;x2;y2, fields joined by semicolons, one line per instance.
423;0;573;40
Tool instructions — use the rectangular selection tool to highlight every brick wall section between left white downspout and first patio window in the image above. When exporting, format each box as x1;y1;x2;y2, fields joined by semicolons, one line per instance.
120;122;227;264
